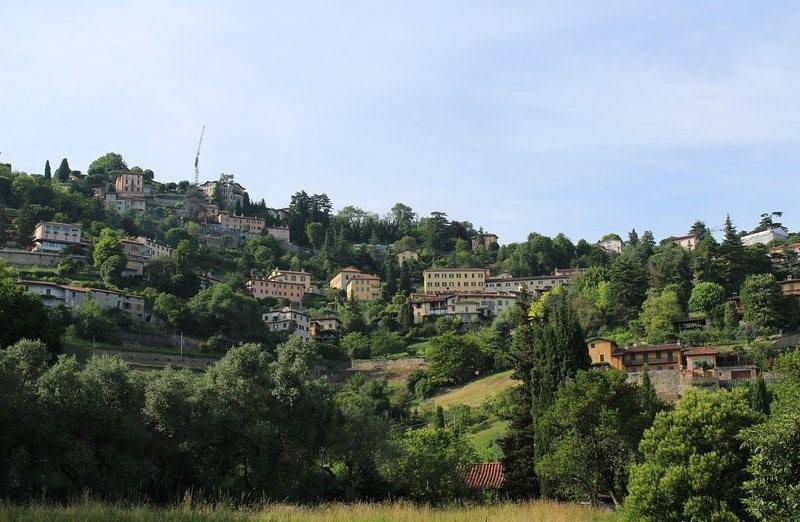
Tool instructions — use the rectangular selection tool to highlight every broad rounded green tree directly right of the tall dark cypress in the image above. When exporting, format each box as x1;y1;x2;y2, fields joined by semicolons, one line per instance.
536;370;653;505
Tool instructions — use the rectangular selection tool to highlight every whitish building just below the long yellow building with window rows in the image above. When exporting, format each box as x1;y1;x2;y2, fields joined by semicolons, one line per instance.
410;292;517;324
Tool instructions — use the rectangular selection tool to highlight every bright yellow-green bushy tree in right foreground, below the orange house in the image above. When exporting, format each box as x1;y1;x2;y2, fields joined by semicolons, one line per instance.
624;389;760;522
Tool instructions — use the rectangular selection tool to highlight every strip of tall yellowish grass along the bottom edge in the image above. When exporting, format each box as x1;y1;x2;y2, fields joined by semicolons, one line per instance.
0;501;613;522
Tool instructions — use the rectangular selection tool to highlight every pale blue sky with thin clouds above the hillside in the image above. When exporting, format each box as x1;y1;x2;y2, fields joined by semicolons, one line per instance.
0;0;800;243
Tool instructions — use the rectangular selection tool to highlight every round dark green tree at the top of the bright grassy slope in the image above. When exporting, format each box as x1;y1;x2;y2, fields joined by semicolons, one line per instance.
427;332;488;384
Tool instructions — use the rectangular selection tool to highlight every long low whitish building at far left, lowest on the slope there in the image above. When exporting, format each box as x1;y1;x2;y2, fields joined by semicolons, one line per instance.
19;280;148;322
